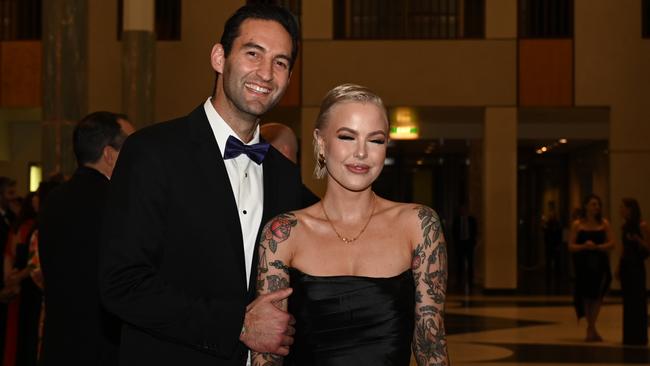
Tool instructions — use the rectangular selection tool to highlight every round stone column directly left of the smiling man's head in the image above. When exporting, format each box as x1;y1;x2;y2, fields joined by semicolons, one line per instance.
122;0;156;128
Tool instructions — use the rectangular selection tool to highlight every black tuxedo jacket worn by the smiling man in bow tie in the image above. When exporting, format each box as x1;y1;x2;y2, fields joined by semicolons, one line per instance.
100;105;301;366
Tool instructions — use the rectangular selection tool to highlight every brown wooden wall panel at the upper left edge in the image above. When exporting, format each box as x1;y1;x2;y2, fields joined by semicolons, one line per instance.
0;41;42;107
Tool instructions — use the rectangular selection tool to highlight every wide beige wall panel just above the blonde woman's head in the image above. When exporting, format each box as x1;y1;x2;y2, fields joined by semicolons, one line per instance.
303;40;517;106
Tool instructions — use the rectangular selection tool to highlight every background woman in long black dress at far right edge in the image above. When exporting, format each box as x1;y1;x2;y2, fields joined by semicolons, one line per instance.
617;198;650;345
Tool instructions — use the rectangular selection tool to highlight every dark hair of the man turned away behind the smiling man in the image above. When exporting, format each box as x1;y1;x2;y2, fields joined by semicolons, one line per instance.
72;111;127;166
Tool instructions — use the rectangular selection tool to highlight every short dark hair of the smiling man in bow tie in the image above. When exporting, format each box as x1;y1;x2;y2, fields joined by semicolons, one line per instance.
220;4;300;69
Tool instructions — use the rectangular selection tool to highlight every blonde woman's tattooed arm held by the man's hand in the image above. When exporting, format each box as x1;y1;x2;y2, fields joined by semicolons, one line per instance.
251;213;298;366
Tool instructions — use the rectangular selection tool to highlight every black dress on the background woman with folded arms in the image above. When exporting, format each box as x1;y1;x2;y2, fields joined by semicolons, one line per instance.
573;230;612;318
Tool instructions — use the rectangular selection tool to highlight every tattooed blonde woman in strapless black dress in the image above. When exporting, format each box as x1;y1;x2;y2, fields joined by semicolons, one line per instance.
253;84;448;366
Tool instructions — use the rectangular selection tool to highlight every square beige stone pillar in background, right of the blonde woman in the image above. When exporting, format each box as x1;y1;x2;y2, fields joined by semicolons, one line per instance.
481;107;517;290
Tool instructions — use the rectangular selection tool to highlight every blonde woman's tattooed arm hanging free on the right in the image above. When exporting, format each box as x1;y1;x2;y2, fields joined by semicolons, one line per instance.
412;206;449;366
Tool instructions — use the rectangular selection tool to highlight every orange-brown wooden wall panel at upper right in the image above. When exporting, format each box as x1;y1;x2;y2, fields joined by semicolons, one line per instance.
518;39;573;106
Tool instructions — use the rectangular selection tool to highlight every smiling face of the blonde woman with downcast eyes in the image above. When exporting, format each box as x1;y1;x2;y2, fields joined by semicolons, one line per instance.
314;102;388;191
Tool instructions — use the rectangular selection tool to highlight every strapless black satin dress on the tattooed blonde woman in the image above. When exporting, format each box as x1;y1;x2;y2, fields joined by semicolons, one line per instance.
284;268;415;366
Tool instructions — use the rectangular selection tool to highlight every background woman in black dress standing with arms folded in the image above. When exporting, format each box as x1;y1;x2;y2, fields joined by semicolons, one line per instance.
569;194;614;342
